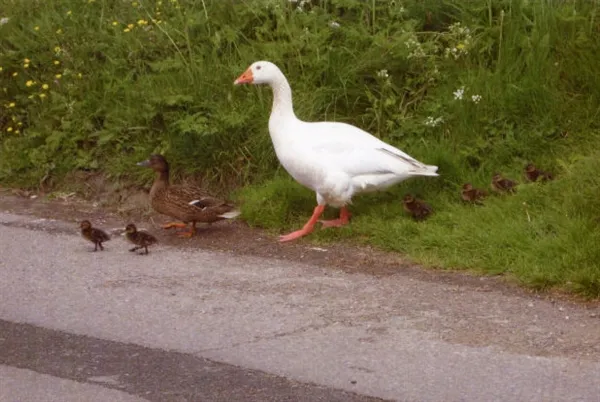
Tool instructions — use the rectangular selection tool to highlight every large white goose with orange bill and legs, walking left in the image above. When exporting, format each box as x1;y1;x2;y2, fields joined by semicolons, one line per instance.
234;61;438;242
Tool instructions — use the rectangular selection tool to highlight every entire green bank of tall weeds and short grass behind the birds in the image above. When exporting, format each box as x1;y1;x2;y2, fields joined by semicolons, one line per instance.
0;0;600;297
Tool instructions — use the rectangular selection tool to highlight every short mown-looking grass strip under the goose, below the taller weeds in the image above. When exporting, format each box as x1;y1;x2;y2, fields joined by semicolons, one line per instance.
239;153;600;297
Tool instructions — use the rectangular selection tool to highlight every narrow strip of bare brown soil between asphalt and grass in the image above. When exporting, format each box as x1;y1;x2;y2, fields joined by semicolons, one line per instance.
0;184;598;307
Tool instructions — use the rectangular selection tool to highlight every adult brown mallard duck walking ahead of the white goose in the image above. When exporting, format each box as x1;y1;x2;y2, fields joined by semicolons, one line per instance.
138;155;240;237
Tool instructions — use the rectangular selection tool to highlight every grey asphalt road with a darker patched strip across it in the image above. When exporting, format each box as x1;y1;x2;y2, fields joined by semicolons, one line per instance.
0;213;600;402
